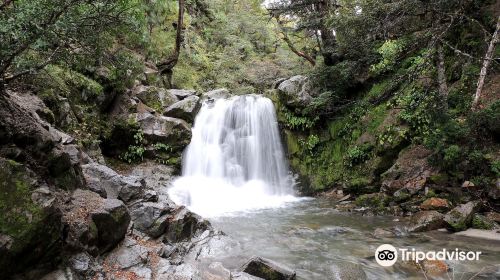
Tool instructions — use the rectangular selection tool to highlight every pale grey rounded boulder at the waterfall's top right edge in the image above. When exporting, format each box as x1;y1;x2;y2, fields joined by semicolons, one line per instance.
278;75;317;109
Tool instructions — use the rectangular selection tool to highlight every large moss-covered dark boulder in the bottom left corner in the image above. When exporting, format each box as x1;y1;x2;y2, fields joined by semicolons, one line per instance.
0;158;63;279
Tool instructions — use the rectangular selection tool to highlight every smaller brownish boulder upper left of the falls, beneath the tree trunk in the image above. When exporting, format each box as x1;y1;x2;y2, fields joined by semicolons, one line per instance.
132;85;179;111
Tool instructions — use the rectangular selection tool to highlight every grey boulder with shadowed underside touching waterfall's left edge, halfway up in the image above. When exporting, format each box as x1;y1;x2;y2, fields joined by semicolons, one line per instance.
135;113;191;148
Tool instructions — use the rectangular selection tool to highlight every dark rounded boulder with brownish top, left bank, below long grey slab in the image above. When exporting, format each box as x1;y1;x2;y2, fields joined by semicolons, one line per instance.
91;199;130;252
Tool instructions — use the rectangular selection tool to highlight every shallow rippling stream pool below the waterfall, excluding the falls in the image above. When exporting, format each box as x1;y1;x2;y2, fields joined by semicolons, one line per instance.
204;199;500;279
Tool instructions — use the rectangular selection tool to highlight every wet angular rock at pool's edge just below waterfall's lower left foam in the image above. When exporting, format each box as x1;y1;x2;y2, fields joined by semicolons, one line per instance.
165;206;209;243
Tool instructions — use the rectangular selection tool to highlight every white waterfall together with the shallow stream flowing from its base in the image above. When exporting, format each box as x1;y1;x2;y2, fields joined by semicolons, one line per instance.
169;95;500;279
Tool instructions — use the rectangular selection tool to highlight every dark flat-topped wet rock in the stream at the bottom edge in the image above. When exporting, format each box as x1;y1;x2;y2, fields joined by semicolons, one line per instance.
241;257;296;280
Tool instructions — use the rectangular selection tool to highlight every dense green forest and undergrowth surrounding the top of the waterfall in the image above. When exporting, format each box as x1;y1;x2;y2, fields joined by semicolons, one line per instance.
0;0;500;203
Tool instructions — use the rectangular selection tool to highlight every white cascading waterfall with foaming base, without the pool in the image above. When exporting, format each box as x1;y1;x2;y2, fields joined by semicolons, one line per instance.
169;95;297;217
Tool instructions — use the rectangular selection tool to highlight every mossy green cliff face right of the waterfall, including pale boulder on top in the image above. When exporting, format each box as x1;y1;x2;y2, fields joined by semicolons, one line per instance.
267;72;499;221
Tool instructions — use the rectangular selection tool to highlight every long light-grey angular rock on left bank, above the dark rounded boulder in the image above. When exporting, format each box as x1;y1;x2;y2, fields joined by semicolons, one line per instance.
82;162;145;202
